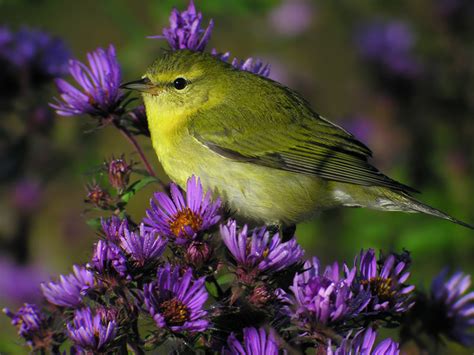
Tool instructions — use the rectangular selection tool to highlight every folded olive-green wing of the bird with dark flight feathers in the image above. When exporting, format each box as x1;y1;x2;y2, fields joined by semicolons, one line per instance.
189;82;416;192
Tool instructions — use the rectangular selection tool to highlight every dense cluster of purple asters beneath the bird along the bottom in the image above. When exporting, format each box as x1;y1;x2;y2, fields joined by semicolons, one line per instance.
6;176;474;355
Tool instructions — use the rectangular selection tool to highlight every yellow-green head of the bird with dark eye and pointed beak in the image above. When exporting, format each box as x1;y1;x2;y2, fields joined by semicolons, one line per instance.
122;50;235;123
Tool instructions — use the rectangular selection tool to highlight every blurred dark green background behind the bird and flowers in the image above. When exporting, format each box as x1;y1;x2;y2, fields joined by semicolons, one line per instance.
0;0;474;354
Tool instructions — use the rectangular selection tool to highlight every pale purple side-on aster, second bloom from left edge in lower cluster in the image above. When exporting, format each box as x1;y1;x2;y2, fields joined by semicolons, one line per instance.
41;265;96;307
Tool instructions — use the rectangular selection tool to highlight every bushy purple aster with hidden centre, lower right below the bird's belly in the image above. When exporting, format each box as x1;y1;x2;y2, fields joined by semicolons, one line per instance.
279;257;370;333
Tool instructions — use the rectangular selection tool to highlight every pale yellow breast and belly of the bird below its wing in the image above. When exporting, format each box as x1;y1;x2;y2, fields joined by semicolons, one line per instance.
154;137;336;224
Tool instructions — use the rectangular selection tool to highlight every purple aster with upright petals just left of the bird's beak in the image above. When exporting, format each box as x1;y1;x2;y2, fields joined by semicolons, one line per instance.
50;45;124;117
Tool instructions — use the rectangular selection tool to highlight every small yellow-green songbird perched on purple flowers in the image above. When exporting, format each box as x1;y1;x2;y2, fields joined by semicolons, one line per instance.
123;50;473;231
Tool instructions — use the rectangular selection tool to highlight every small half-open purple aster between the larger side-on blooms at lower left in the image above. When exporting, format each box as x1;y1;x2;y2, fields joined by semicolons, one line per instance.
91;240;129;280
